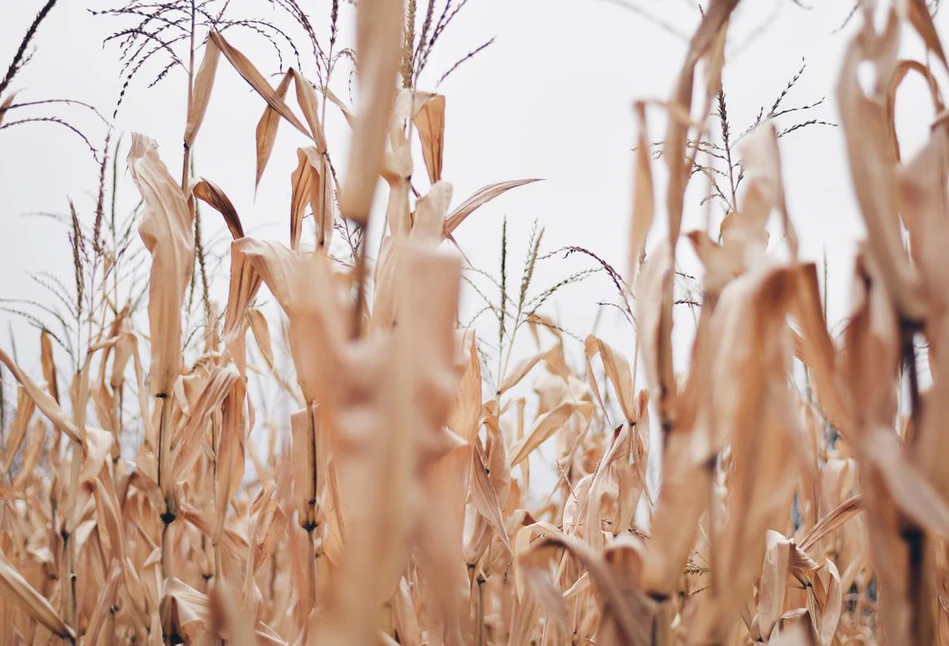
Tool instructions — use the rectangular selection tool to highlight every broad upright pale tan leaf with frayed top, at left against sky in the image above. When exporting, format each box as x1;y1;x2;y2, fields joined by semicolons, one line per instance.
128;134;194;395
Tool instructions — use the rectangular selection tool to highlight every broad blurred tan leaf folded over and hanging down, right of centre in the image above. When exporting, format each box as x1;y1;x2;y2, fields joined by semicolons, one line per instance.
710;267;804;636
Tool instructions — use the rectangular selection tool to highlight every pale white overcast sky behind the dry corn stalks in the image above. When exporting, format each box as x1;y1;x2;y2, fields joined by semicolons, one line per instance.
0;0;946;394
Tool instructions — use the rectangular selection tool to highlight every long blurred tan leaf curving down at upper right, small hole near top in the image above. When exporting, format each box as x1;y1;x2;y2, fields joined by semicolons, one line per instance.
837;12;926;320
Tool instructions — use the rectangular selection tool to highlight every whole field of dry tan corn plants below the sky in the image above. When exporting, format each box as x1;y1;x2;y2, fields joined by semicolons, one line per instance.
0;0;949;646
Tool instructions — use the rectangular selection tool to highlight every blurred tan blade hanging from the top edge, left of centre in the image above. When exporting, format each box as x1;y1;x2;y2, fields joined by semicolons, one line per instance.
339;0;403;223
